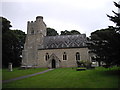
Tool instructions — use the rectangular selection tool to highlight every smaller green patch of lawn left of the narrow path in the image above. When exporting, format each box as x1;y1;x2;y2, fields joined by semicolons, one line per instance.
2;68;47;80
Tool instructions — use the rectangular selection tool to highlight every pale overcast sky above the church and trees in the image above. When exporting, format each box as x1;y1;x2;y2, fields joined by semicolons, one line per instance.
0;0;119;36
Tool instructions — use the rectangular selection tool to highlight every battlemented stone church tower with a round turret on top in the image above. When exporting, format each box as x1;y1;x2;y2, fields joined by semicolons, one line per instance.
22;16;46;66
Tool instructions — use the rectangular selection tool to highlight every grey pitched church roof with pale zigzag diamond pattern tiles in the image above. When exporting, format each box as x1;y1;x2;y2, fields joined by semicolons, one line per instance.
39;34;87;49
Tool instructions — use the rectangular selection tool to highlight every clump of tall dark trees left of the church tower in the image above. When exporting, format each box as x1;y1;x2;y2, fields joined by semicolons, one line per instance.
0;17;25;67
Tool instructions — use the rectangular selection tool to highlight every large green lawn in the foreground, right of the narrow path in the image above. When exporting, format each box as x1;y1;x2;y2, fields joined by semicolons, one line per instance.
3;67;120;88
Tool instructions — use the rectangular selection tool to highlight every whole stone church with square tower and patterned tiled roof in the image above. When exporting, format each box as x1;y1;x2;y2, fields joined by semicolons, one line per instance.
22;16;90;68
